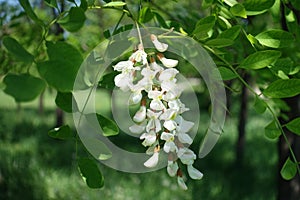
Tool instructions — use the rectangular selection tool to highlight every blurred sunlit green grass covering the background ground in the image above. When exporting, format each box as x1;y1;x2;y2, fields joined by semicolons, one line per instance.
0;92;277;200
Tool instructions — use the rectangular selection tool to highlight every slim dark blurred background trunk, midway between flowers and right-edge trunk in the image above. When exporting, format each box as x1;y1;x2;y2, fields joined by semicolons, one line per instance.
236;74;249;164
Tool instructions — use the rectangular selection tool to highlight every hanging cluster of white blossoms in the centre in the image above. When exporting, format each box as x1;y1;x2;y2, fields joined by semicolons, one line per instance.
114;34;203;190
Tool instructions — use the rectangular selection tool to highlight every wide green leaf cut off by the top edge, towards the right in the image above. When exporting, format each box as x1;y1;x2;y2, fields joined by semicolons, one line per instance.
243;0;275;15
